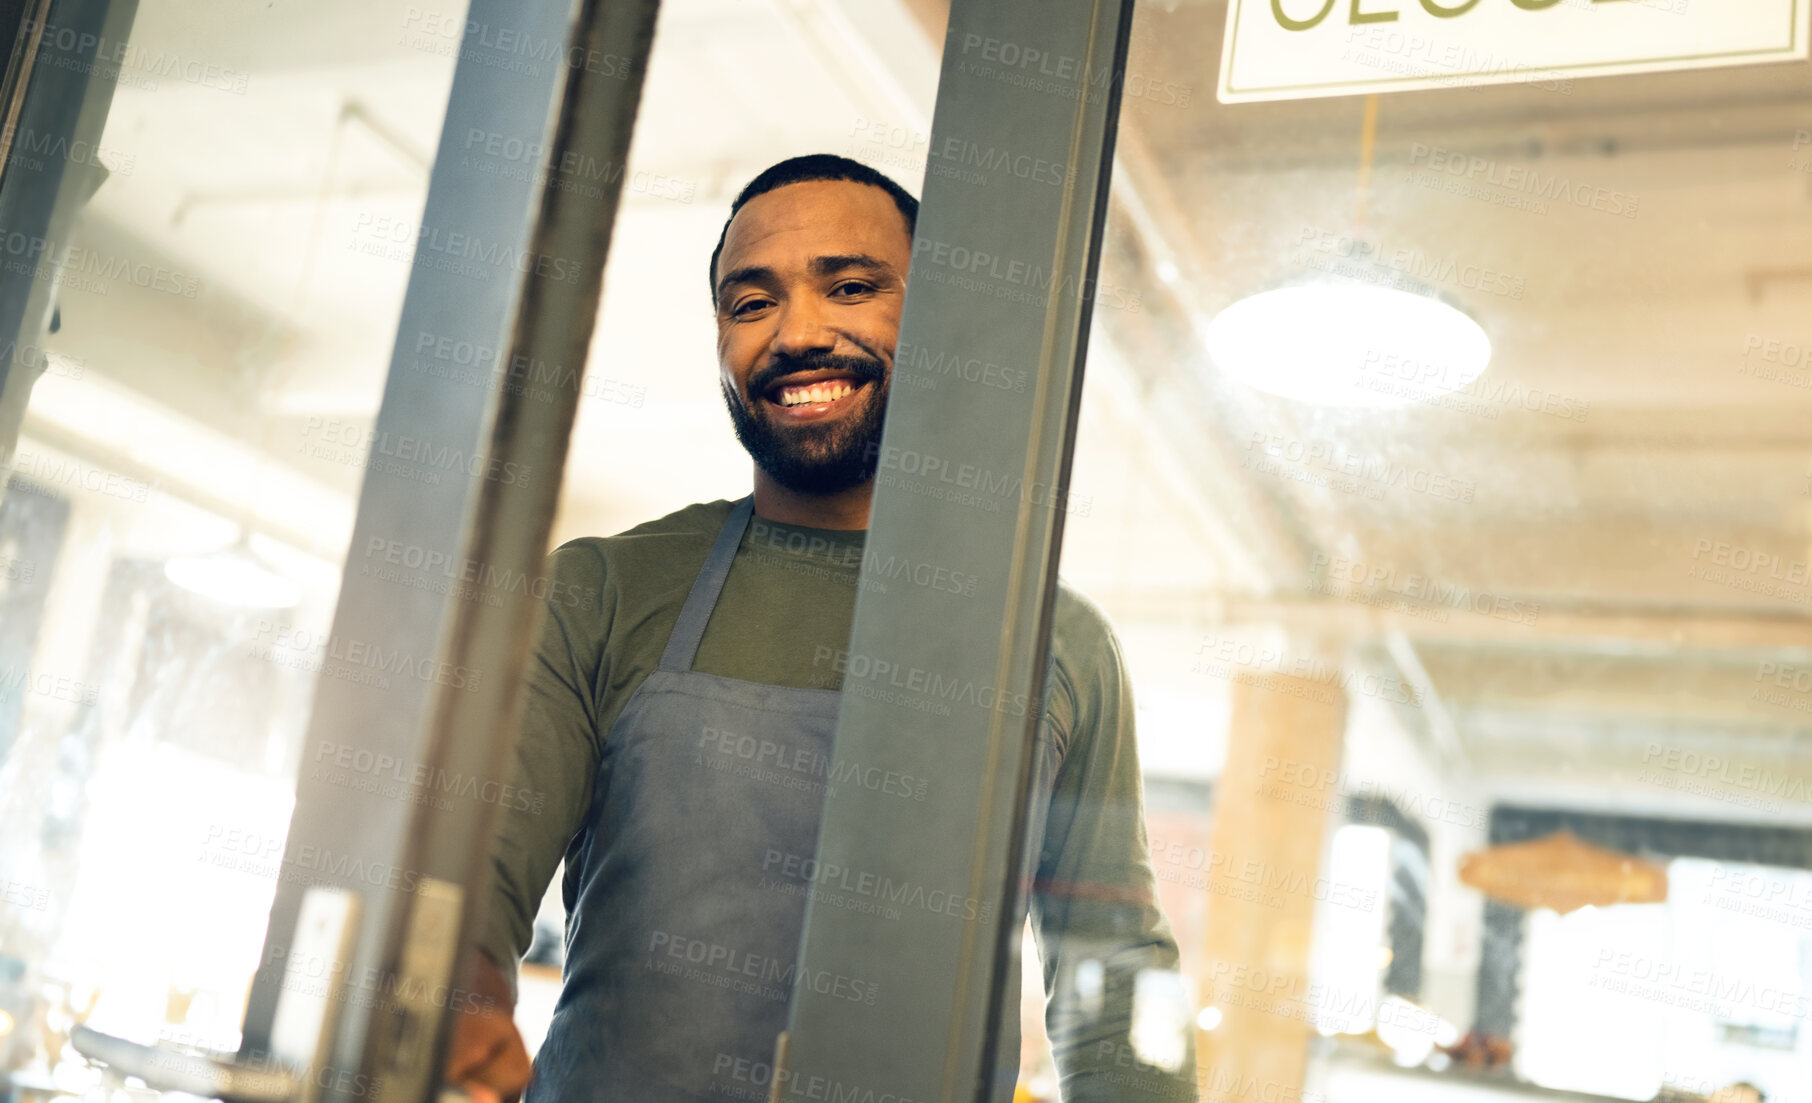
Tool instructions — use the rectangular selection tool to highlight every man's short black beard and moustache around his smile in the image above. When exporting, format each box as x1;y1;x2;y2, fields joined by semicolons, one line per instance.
721;353;888;494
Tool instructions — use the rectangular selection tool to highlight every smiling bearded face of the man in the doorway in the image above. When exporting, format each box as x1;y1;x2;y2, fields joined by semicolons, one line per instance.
716;179;911;494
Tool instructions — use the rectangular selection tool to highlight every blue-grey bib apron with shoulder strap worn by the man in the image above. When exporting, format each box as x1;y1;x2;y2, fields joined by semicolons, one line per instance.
527;498;1044;1103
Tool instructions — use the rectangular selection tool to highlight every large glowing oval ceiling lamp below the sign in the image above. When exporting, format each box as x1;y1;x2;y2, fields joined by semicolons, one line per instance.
1203;279;1491;408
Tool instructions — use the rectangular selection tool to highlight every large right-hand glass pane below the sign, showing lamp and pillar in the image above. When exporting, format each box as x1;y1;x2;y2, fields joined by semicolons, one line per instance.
1087;4;1812;1103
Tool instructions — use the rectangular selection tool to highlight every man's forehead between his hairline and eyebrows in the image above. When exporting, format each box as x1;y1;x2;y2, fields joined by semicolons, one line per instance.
723;179;911;268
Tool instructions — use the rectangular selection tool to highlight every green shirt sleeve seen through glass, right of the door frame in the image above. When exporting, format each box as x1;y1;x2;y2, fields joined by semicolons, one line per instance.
1031;587;1196;1103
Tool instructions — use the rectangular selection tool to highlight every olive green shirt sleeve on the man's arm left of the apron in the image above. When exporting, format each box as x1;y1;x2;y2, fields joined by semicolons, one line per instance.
477;543;611;998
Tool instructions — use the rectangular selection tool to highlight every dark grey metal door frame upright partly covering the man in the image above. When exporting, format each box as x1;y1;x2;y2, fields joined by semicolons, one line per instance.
770;0;1133;1101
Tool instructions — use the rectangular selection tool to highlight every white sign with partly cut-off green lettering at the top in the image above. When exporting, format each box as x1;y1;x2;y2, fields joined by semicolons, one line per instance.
1219;0;1812;103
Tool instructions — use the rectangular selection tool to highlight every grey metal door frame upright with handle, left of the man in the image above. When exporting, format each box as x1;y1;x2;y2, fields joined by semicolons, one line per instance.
230;0;658;1099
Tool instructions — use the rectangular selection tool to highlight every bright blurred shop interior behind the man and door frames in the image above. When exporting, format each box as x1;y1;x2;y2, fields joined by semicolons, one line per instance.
0;0;1812;1103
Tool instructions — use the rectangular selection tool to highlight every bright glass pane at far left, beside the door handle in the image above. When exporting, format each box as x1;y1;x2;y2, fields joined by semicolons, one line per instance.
0;0;464;1094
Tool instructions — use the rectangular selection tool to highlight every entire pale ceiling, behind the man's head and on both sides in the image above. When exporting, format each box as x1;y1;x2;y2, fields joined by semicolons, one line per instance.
25;0;1812;822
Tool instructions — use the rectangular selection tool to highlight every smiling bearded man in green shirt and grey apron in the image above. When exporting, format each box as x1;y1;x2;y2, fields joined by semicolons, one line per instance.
448;156;1194;1103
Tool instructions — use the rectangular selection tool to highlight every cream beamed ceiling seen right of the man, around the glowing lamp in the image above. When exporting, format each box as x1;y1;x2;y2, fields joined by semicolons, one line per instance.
1087;4;1812;820
